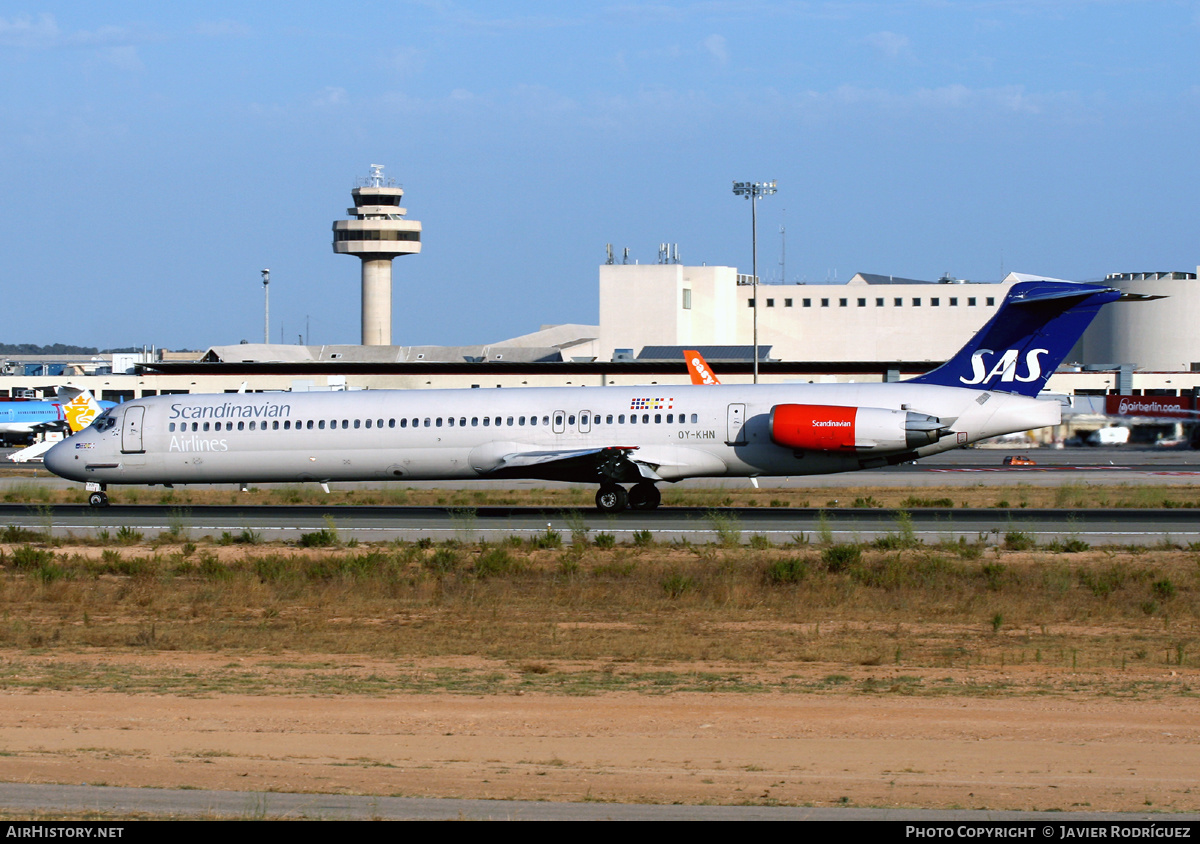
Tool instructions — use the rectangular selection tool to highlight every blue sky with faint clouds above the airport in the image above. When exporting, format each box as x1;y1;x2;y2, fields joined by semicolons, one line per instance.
0;0;1200;348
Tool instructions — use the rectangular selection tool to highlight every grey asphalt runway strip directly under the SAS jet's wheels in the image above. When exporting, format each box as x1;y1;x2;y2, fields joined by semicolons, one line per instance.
9;504;1200;545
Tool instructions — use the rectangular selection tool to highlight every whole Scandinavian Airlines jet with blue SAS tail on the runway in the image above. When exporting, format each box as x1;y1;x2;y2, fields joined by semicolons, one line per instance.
46;281;1135;511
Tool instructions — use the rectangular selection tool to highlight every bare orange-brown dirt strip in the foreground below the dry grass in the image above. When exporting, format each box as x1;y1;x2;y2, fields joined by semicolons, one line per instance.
0;652;1200;813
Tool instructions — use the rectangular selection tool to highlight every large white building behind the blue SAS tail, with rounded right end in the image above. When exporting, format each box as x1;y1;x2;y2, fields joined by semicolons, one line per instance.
599;264;1200;371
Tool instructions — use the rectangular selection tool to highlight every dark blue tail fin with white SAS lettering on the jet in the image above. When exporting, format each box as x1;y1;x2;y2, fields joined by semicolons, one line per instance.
911;281;1121;396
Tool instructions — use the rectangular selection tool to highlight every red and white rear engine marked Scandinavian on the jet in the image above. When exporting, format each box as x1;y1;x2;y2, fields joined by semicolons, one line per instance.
770;405;947;453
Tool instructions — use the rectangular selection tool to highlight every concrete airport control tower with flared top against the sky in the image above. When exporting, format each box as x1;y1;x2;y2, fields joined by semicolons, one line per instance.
334;164;421;346
